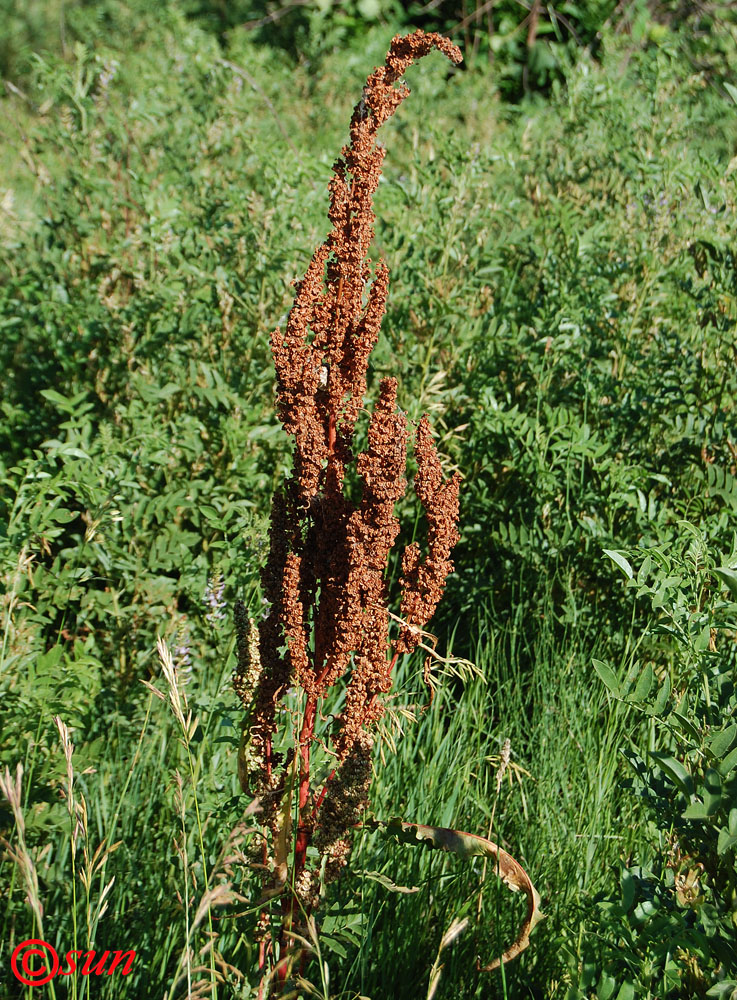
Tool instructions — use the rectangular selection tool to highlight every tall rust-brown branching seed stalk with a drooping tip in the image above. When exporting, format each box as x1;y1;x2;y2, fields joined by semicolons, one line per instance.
234;31;461;982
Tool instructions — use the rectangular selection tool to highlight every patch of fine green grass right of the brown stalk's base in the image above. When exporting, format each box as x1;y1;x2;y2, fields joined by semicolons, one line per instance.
334;596;638;997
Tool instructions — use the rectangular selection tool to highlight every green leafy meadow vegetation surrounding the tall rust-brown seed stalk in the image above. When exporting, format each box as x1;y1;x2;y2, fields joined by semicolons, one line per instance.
0;0;737;1000
